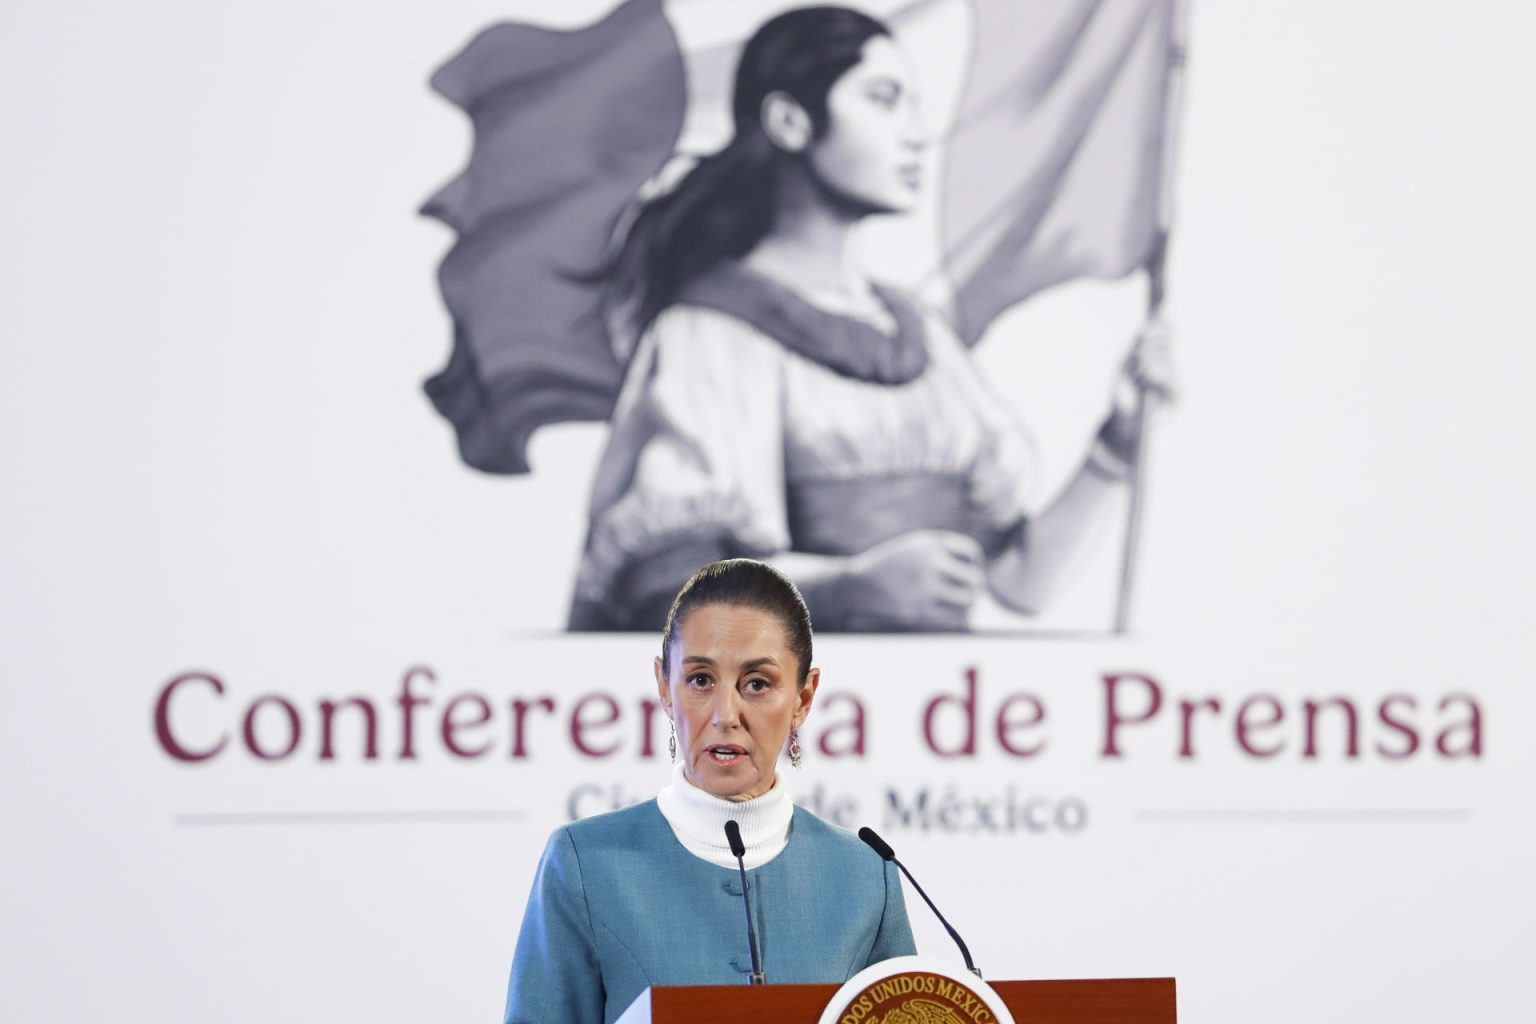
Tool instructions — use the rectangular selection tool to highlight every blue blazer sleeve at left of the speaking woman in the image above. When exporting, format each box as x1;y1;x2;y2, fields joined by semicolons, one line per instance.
505;829;604;1024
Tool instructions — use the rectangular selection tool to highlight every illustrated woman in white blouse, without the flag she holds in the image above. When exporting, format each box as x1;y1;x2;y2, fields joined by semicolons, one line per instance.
570;8;1167;631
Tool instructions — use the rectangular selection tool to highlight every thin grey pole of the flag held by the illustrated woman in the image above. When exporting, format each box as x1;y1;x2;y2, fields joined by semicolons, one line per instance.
1115;0;1189;634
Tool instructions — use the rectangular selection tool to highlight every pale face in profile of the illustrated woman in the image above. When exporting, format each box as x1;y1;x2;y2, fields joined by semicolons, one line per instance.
806;35;926;213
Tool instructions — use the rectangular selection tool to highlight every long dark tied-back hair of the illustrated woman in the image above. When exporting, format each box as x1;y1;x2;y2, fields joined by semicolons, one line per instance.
610;6;891;335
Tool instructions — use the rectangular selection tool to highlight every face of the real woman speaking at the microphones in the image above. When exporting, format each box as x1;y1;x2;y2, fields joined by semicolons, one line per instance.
656;605;820;800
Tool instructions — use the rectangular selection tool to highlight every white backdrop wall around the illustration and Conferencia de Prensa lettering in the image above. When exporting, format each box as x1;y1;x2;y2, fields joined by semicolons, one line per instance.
0;0;1536;1021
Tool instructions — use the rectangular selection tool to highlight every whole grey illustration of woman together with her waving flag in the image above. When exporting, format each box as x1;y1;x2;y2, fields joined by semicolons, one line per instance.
425;0;1178;633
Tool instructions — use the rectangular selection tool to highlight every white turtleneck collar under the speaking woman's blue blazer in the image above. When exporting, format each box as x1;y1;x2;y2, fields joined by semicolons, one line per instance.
656;765;794;870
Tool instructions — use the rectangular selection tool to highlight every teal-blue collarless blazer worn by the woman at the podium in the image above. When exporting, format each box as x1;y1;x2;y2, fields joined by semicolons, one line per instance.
505;800;915;1024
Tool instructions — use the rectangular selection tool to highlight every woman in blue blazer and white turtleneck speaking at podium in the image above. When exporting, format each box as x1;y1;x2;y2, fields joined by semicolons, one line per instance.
505;559;915;1024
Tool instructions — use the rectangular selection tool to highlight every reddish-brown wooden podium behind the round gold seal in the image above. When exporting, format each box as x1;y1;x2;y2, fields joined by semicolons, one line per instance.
616;978;1178;1024
